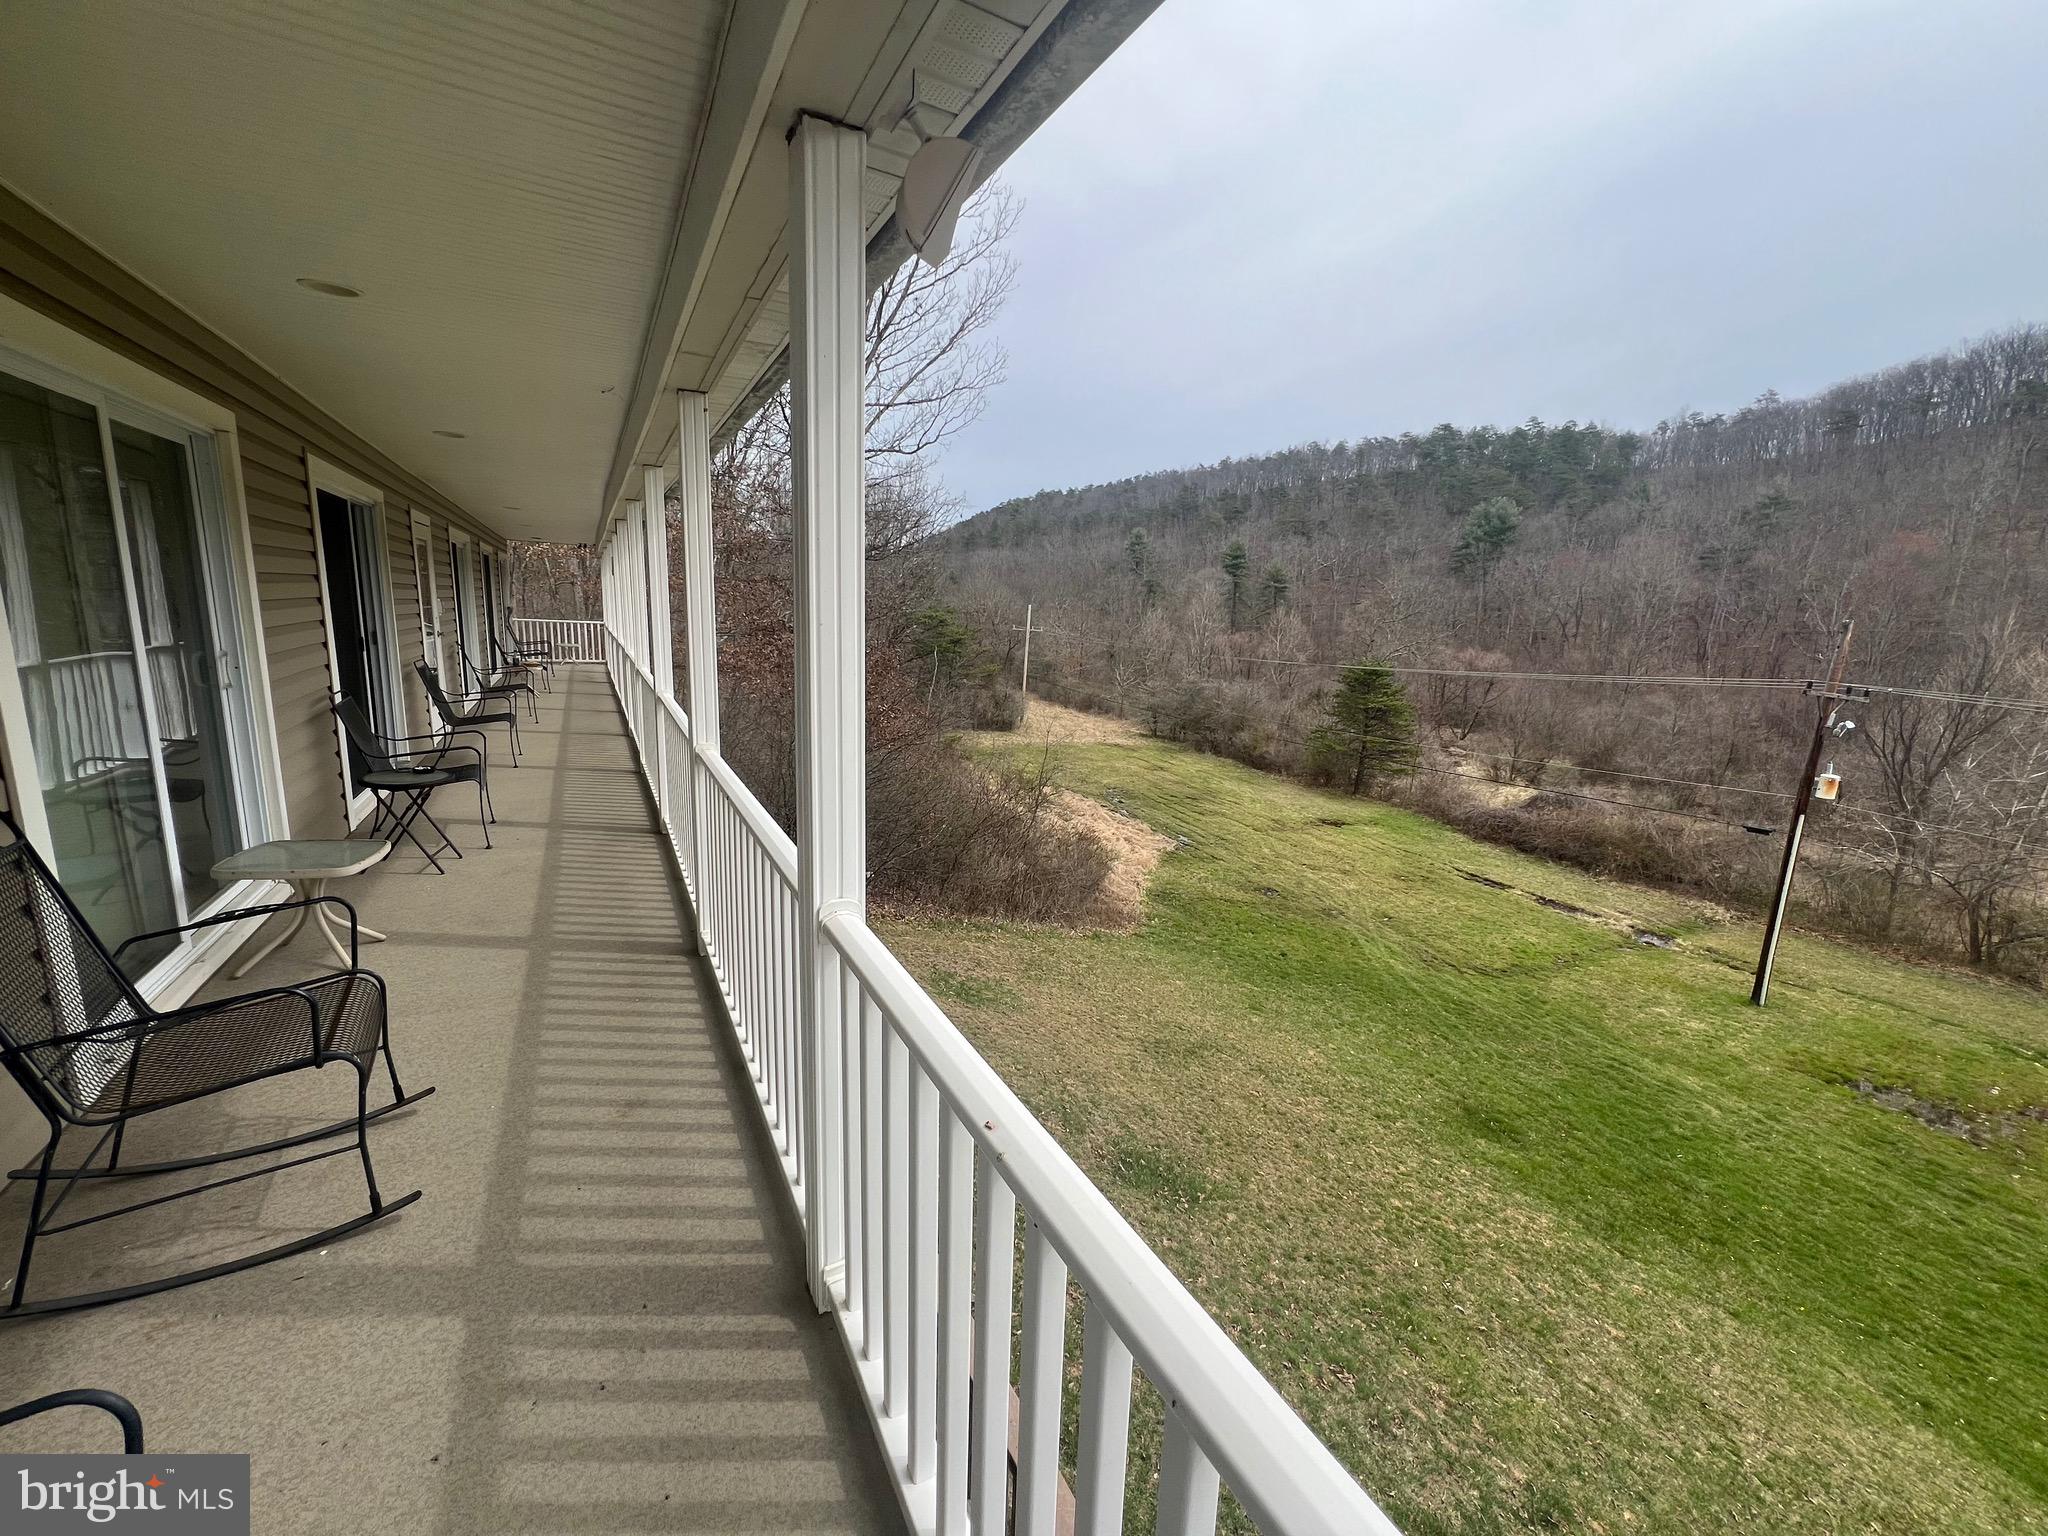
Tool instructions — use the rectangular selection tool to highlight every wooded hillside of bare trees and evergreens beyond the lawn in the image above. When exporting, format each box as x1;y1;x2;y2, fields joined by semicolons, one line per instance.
934;326;2048;975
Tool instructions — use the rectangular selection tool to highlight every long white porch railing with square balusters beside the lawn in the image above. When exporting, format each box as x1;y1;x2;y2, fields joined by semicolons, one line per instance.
606;629;1395;1536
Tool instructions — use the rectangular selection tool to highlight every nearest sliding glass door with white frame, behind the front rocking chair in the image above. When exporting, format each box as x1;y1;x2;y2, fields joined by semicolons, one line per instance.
0;358;270;975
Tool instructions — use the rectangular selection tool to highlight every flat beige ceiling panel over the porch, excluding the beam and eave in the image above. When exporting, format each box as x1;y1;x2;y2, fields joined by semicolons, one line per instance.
0;0;729;539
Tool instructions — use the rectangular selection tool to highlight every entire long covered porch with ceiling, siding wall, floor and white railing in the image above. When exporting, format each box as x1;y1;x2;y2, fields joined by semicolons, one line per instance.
0;0;1391;1536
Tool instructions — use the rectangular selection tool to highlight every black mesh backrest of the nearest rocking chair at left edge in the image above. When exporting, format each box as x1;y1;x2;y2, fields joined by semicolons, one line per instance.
0;815;147;1118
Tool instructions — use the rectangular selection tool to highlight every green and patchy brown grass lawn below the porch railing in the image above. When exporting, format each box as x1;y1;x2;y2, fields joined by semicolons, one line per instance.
887;743;2048;1536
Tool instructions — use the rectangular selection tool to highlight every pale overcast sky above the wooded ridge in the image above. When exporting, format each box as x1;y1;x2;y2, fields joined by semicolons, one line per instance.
944;0;2048;510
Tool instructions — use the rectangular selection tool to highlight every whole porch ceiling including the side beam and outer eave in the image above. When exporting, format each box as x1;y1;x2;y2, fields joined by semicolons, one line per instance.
0;0;1157;539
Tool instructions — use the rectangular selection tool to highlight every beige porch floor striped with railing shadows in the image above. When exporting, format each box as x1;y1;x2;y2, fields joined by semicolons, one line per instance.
0;666;901;1532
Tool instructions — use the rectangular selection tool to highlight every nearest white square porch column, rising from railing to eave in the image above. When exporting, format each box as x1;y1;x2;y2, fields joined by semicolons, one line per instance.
788;117;868;1311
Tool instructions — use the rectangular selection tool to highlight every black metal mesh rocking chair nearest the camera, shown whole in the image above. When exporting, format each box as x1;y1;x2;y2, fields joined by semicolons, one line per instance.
0;813;434;1321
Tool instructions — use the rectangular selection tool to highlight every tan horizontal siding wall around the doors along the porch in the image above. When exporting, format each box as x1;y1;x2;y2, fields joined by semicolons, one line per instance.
0;188;500;838
